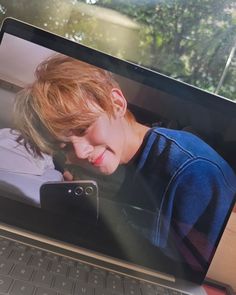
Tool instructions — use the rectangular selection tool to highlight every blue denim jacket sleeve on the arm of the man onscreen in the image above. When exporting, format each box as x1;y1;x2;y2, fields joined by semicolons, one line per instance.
159;159;235;270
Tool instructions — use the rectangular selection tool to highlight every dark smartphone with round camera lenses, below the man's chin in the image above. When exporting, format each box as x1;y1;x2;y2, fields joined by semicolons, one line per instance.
40;180;99;223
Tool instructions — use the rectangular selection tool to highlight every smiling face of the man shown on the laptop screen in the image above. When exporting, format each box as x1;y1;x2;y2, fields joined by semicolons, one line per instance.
62;114;128;175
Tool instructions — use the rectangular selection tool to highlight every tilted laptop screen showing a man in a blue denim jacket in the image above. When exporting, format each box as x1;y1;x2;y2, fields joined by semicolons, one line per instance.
0;19;236;282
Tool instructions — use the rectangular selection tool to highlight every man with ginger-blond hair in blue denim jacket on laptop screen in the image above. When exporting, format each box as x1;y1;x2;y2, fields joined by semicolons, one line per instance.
14;55;236;269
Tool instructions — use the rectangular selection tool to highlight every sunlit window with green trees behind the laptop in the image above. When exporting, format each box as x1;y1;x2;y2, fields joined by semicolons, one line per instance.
0;0;236;100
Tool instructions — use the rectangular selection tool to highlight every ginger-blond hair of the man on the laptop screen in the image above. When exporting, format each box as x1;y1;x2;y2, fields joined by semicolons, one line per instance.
14;54;134;155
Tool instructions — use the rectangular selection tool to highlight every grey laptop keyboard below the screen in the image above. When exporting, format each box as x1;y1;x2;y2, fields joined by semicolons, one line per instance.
0;238;187;295
